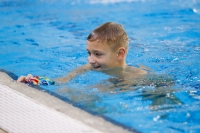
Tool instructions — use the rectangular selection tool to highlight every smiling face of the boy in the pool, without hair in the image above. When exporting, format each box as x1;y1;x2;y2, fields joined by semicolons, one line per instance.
87;41;118;70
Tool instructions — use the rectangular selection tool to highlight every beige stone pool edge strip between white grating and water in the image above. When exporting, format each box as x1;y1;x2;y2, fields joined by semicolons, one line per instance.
0;72;135;133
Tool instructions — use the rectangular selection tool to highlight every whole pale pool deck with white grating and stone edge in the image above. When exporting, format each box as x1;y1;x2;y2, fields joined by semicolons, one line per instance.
0;72;132;133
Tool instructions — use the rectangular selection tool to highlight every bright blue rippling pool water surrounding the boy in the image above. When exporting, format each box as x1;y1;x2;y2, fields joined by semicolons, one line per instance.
0;0;200;133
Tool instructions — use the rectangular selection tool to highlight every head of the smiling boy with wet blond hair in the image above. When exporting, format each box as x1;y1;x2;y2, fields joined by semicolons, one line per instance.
87;22;128;70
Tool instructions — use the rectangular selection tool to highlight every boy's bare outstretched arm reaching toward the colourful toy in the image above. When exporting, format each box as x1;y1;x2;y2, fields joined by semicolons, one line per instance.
55;64;91;83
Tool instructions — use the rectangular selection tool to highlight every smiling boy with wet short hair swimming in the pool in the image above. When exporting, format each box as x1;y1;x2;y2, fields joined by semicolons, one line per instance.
17;22;150;87
